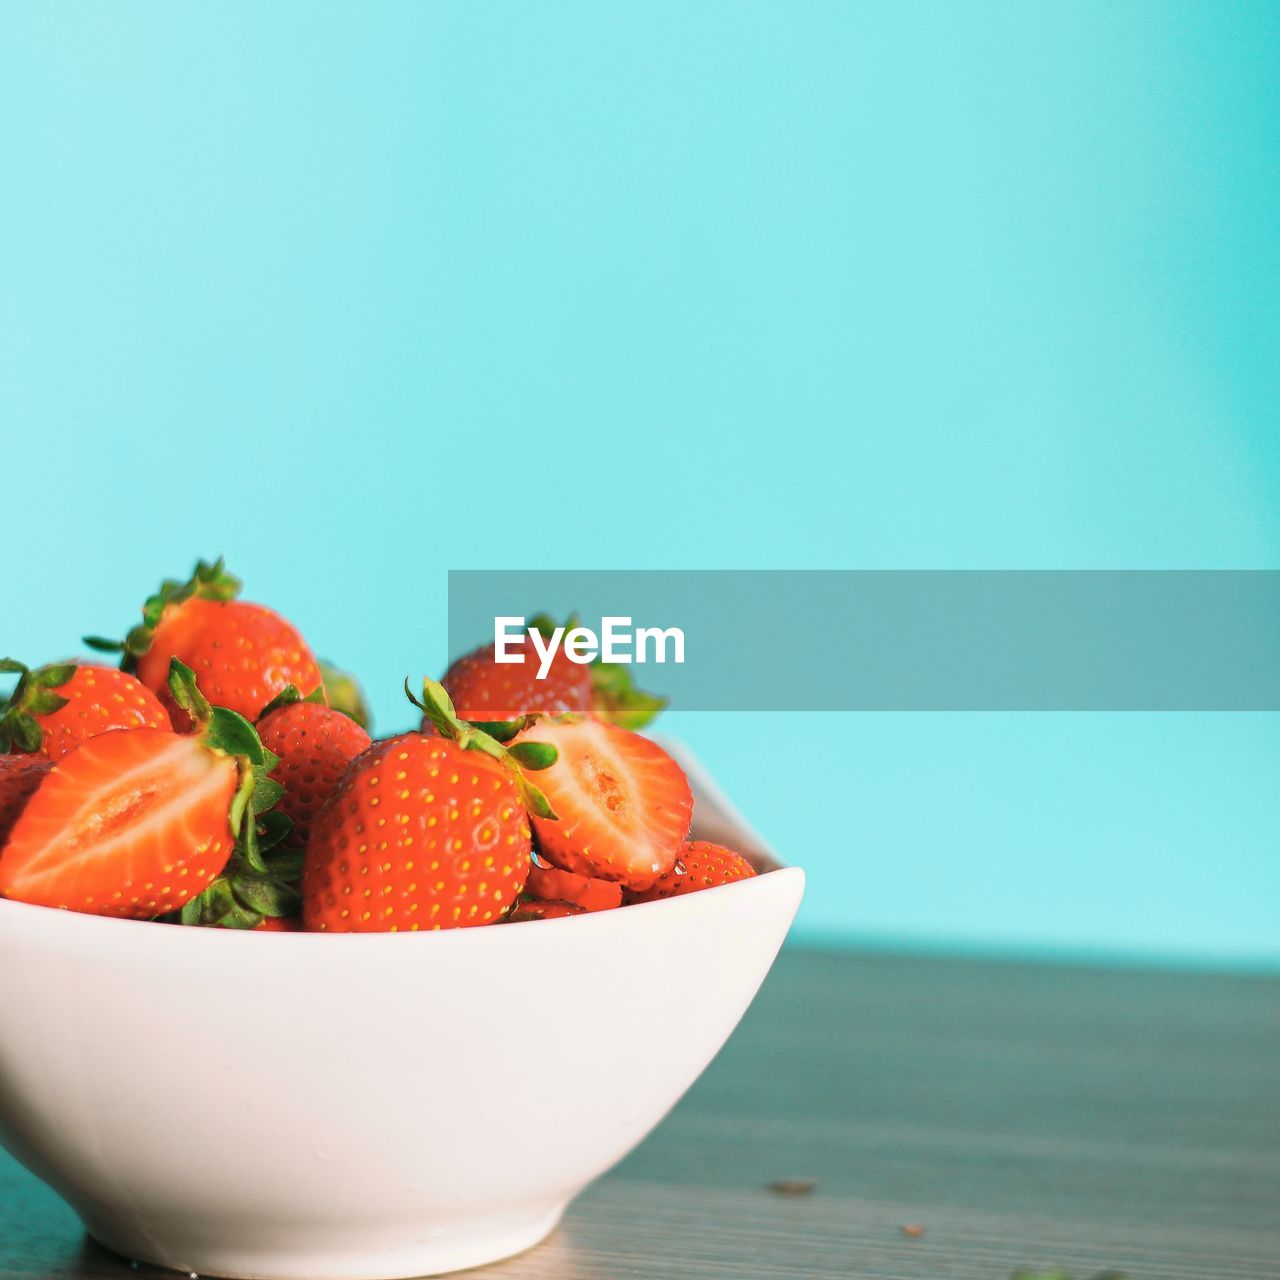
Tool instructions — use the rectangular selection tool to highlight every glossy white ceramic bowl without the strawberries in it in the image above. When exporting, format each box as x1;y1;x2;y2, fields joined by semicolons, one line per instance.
0;849;804;1280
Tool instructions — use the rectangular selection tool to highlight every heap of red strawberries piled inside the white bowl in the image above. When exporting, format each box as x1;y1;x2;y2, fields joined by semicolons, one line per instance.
0;562;755;933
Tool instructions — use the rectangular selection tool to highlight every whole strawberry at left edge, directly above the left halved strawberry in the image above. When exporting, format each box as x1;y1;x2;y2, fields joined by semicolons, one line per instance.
0;658;170;760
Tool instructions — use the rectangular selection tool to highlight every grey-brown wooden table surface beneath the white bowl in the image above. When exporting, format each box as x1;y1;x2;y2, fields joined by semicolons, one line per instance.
0;950;1280;1280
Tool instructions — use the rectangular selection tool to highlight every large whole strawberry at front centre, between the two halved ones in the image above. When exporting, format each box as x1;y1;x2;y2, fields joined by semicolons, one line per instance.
302;682;560;933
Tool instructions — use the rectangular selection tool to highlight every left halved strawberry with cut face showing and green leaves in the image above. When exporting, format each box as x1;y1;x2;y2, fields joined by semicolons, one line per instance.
0;663;296;927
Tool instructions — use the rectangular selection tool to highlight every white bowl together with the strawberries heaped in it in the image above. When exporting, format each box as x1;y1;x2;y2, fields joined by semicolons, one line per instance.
0;563;804;1280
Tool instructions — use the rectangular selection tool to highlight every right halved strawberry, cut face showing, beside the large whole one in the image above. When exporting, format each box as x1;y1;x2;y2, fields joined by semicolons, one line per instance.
516;716;694;888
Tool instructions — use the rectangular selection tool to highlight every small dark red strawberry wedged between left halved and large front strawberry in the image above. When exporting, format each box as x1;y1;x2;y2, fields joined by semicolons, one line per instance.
257;685;370;849
